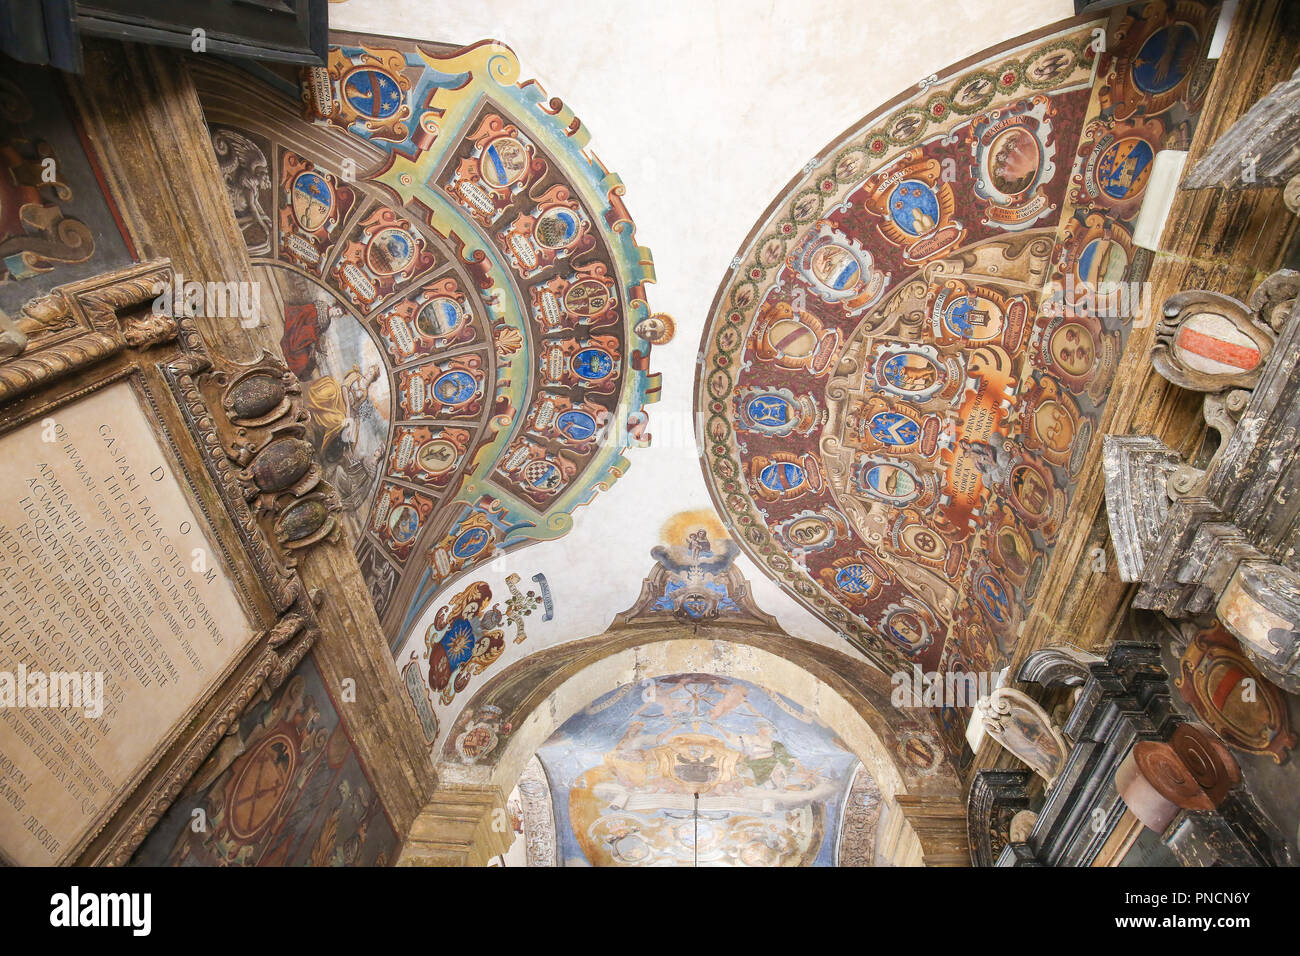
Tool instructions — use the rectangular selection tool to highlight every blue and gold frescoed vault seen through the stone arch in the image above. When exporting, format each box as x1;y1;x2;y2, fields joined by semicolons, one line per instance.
537;674;871;866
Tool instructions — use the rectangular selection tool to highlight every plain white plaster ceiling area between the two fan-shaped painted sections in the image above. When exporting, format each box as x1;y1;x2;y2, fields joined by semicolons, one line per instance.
314;0;1071;671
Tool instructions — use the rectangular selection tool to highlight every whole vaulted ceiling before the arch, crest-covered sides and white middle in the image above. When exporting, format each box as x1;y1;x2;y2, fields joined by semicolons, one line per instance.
194;0;1217;801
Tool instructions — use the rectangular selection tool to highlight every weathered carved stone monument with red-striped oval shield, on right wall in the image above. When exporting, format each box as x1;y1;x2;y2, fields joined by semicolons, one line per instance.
1102;271;1300;693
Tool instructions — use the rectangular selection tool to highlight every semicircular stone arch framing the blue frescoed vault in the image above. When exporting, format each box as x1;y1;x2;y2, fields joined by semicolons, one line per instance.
404;626;969;864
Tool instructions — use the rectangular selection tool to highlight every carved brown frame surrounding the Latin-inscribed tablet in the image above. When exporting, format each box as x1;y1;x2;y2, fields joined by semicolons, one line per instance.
0;259;338;865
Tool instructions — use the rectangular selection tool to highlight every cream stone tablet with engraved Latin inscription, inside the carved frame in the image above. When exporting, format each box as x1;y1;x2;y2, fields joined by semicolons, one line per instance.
0;382;256;865
